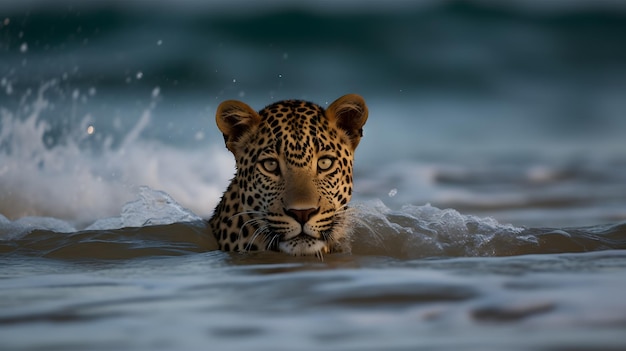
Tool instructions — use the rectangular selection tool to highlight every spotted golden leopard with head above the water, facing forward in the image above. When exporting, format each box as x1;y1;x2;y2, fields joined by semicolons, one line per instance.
208;94;368;258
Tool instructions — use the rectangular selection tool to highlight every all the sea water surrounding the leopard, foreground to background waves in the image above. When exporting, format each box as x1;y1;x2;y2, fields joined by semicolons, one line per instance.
0;1;626;350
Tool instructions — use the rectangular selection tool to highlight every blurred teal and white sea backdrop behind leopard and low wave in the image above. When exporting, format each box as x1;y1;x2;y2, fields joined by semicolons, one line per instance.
0;0;626;226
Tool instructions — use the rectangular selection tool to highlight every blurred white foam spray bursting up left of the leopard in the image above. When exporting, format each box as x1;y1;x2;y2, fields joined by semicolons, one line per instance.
0;81;234;229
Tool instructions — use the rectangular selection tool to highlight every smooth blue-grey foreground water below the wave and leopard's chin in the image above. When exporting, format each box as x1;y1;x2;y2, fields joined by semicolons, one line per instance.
0;251;626;350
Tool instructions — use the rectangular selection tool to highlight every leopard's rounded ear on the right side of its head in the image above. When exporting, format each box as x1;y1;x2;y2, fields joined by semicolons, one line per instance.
326;94;367;149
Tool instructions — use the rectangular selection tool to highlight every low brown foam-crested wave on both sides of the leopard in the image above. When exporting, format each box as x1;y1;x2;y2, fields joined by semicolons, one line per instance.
0;187;626;260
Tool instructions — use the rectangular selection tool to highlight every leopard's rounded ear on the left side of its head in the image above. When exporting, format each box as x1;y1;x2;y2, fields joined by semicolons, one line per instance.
215;100;261;154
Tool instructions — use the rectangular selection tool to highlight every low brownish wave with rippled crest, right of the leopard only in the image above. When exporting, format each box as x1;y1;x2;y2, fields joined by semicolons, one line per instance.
352;201;626;259
